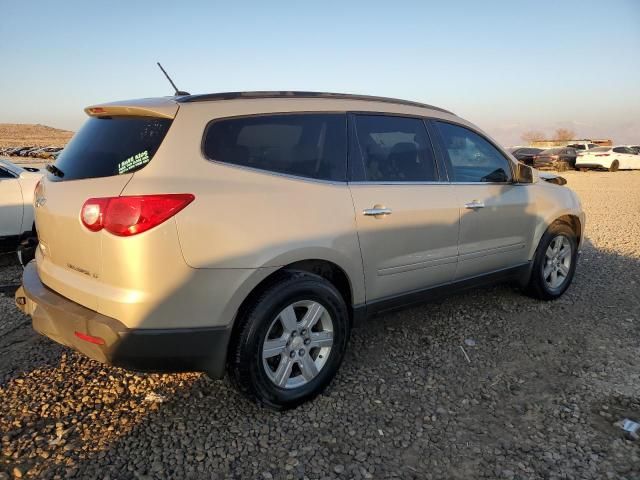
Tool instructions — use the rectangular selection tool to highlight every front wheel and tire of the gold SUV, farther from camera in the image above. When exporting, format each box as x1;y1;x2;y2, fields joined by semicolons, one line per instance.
526;222;578;300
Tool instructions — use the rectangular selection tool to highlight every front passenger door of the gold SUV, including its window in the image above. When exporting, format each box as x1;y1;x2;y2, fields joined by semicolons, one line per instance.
432;120;536;280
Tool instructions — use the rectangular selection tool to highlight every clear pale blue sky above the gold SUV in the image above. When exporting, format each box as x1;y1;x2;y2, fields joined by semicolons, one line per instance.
0;0;640;146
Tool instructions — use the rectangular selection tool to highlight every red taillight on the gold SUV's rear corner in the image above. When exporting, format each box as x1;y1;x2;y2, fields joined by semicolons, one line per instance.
80;193;195;237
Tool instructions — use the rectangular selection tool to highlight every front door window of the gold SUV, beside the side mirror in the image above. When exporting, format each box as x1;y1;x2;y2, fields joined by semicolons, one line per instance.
436;121;512;182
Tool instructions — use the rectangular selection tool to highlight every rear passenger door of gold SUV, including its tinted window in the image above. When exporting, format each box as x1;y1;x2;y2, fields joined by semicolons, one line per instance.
349;114;459;302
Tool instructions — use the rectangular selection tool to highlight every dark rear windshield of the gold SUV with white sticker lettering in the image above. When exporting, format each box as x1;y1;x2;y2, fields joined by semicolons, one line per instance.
49;117;171;180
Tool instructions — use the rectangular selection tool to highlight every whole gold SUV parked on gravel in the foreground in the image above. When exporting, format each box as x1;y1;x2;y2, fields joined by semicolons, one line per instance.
16;92;584;409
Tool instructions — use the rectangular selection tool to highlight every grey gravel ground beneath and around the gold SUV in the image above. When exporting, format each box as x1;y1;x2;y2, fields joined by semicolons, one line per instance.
0;172;640;479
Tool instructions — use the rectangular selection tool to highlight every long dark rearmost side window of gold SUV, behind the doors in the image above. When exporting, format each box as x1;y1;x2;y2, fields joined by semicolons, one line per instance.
204;113;347;182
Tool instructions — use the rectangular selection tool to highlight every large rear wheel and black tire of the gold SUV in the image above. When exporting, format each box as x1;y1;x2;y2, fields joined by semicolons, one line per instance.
228;271;351;410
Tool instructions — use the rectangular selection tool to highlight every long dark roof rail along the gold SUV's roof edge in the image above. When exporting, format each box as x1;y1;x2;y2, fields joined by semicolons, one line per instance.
176;91;455;115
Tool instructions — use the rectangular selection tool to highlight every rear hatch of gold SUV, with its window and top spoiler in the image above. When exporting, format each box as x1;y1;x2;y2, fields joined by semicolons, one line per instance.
35;103;178;310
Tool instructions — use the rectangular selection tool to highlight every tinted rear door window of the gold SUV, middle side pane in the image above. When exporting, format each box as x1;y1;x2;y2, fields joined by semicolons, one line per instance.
355;115;437;182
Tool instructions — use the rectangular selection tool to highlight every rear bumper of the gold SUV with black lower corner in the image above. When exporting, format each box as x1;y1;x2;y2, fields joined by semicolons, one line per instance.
16;262;231;378
